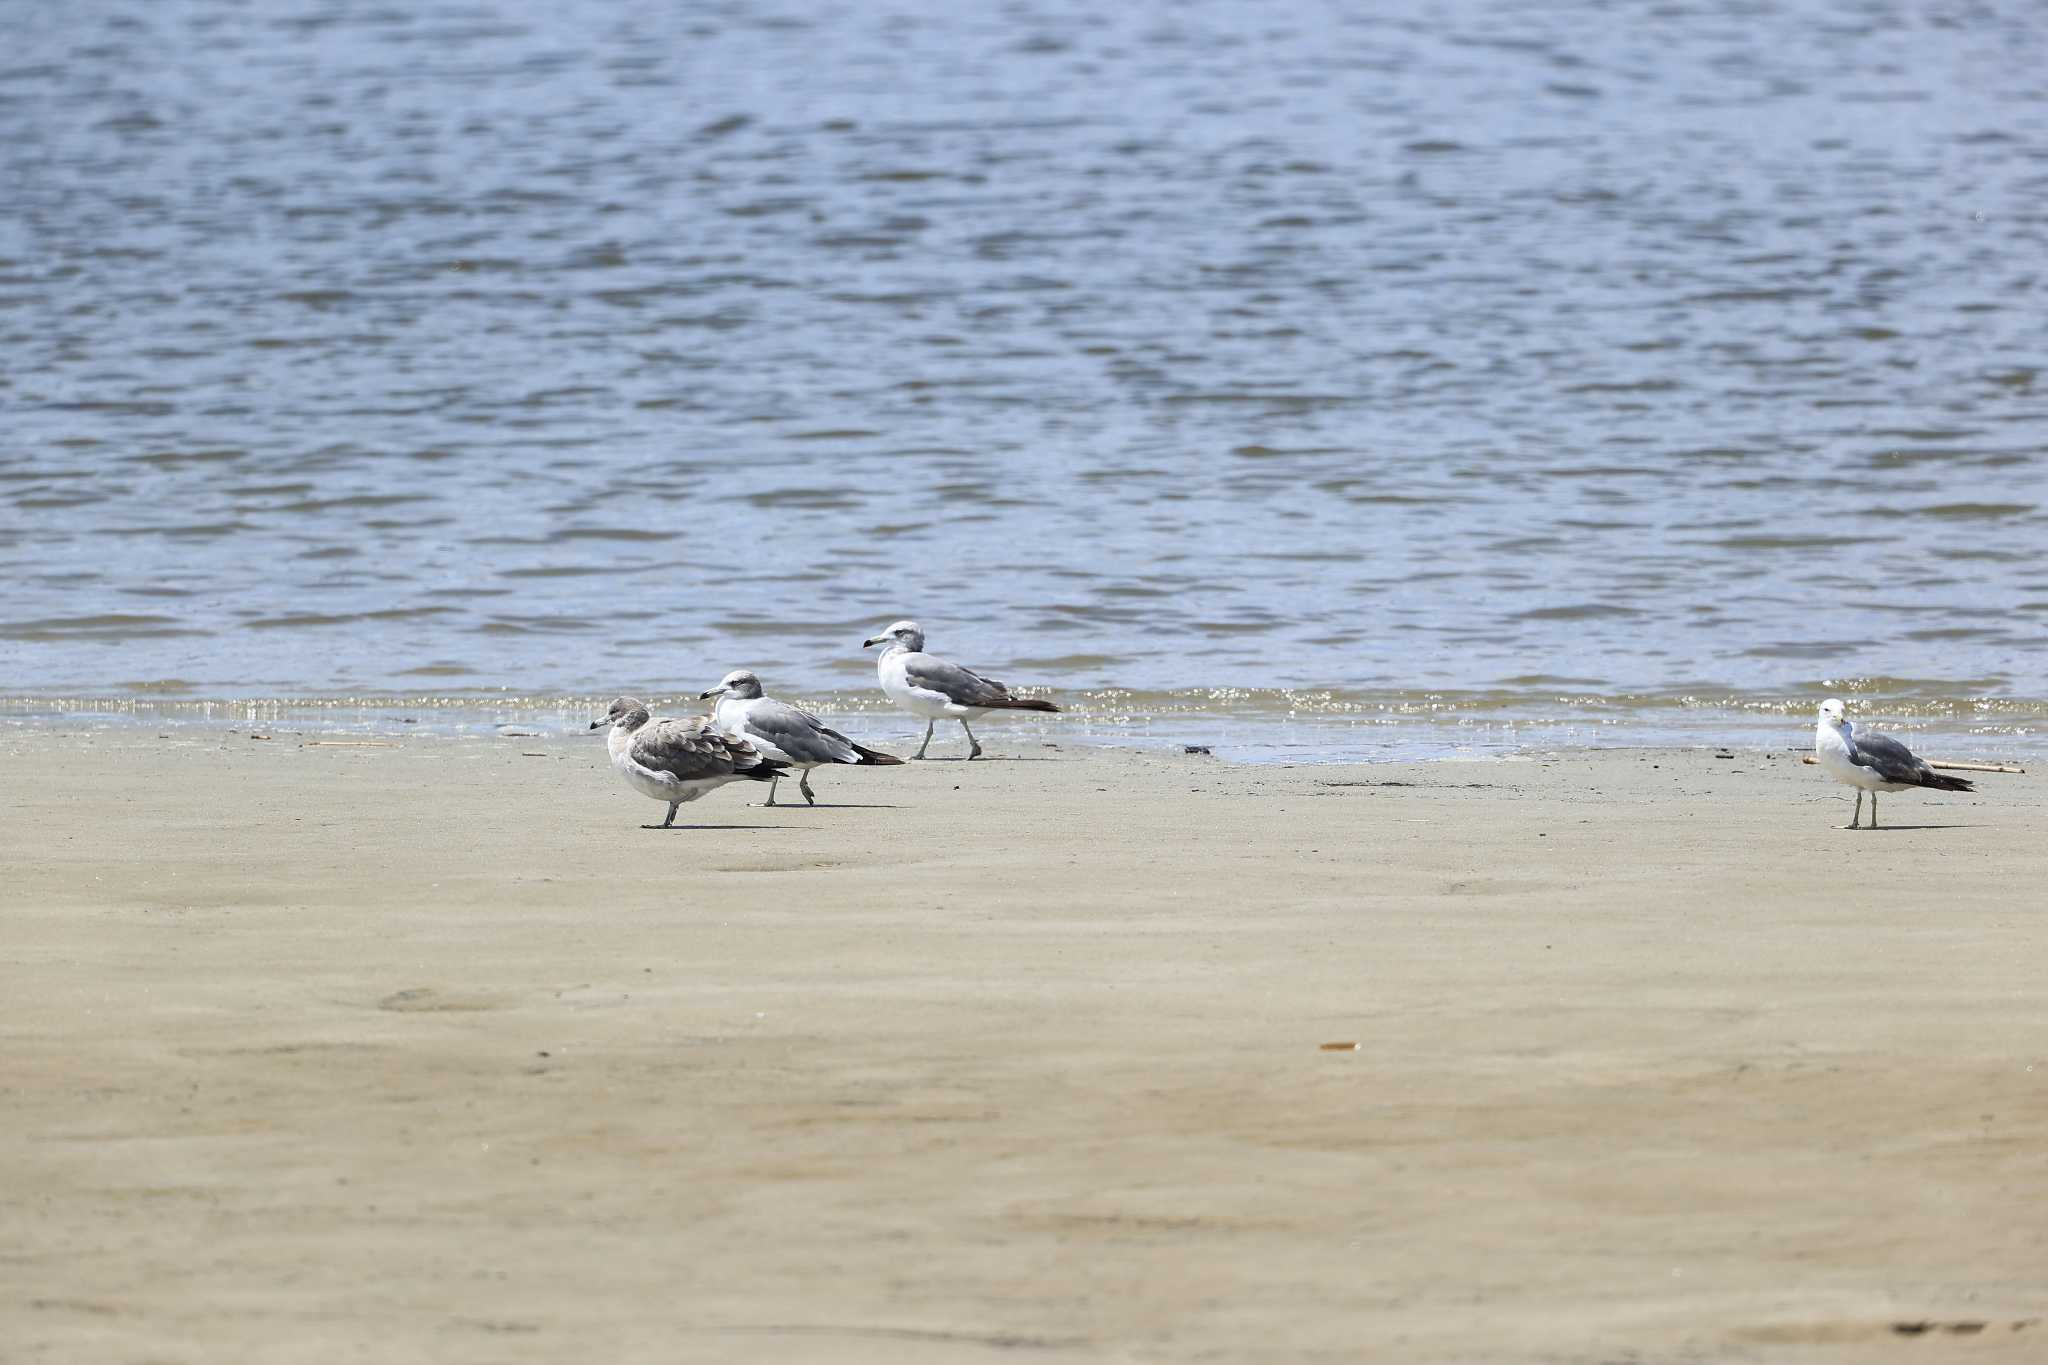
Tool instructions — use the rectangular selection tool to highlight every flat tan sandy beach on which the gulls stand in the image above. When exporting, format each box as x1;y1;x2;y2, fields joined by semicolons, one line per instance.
0;726;2048;1365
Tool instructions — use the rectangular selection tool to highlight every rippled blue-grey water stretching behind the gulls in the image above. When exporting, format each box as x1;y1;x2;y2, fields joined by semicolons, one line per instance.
0;0;2048;757
